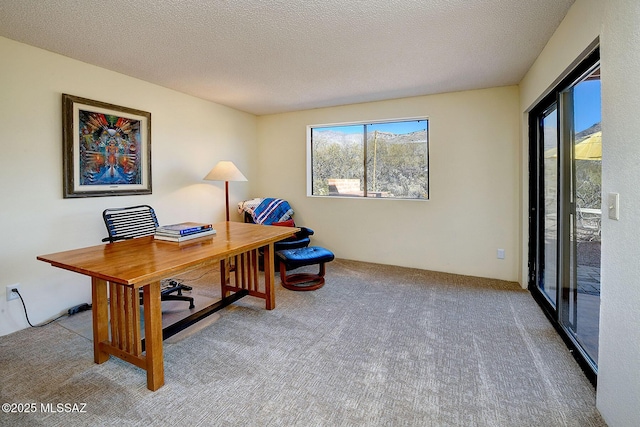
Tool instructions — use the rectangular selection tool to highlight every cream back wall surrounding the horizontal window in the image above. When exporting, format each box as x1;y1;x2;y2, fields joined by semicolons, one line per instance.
253;86;520;281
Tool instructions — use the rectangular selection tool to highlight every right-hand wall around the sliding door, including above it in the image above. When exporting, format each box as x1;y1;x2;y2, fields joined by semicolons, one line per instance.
520;0;640;427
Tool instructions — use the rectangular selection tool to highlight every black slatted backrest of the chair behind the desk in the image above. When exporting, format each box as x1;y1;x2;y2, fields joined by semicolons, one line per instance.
102;205;158;242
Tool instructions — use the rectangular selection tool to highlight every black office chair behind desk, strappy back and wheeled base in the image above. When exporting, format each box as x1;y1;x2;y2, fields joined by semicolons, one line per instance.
102;205;195;309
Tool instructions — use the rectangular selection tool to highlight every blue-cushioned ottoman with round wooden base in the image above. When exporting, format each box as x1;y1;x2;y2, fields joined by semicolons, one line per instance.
276;246;334;291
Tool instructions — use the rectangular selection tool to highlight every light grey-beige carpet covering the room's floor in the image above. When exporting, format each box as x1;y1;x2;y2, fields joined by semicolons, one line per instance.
0;260;605;427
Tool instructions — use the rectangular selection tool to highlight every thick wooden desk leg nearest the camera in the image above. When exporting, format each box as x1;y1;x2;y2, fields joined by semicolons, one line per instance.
142;282;164;391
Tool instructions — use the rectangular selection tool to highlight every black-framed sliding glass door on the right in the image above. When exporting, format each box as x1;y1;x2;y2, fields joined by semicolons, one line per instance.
529;50;602;382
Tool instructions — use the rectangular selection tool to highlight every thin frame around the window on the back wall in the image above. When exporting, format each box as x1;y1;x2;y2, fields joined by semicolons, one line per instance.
306;116;431;202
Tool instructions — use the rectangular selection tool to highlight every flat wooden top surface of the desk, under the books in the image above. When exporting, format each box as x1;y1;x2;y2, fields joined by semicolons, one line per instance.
37;222;299;287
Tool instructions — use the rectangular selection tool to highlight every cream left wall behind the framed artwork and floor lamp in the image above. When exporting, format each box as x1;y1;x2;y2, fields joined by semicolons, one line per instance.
0;38;257;335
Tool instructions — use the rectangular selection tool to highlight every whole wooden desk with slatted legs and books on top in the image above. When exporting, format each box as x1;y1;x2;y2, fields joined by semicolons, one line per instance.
37;222;298;391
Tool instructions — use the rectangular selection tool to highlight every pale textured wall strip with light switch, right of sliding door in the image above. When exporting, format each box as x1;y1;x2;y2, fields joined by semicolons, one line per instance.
598;0;640;427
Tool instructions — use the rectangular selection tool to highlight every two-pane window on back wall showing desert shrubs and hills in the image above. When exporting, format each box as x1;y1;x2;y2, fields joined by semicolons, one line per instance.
308;118;429;200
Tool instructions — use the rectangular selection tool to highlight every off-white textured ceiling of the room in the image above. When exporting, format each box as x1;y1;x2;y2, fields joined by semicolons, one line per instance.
0;0;574;115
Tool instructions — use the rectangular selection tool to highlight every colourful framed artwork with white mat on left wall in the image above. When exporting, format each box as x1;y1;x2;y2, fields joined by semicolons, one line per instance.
62;94;151;198
